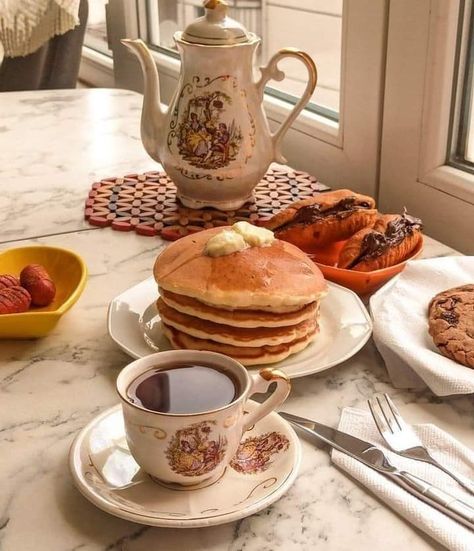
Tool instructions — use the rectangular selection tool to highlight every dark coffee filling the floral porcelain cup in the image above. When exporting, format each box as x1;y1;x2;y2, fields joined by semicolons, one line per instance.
127;363;241;414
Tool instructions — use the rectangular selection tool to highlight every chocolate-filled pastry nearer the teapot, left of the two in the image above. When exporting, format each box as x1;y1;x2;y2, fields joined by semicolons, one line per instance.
261;189;377;250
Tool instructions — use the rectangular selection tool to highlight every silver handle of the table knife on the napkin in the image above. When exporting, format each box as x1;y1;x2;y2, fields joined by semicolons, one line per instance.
391;471;474;530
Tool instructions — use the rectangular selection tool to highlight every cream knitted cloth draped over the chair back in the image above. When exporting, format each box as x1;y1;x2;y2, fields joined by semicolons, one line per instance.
0;0;80;57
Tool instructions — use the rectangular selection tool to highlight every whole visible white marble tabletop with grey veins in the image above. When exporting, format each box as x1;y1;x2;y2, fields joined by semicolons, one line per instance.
0;90;468;551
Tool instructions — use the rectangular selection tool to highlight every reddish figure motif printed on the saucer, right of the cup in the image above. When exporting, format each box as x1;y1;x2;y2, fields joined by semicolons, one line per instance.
230;432;290;474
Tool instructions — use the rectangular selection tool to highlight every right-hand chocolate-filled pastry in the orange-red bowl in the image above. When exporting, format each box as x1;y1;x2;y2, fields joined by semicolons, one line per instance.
338;212;422;272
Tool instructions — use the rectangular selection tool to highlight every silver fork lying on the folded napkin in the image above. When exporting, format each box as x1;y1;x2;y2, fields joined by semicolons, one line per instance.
368;394;474;494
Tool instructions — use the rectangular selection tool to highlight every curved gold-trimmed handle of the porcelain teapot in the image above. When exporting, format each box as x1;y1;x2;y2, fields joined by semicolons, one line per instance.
257;48;318;163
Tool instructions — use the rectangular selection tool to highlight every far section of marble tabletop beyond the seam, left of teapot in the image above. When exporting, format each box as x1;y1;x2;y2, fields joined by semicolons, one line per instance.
0;89;152;243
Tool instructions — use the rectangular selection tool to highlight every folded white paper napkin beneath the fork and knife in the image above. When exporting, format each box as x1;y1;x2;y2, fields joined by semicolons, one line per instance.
332;408;474;551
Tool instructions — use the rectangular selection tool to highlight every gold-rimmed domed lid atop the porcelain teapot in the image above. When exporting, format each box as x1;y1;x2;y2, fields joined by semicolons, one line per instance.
181;0;251;46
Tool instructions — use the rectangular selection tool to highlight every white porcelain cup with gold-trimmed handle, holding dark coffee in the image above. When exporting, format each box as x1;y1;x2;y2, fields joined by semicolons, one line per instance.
117;350;290;486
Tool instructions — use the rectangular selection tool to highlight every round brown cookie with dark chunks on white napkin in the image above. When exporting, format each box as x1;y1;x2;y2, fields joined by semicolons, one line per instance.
428;285;474;369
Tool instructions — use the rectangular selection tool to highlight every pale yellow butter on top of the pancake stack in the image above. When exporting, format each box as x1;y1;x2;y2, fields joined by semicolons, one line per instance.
204;221;275;256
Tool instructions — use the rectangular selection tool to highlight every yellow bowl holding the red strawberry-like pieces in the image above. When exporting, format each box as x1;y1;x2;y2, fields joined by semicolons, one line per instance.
0;246;87;339
